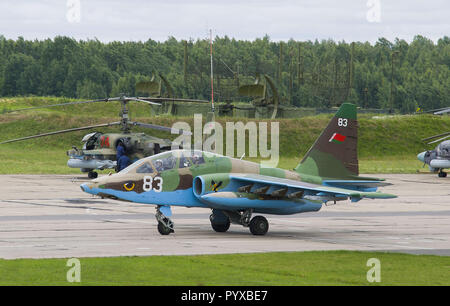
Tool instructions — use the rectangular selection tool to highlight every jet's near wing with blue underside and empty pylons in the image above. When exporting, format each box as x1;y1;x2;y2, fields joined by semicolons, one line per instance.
202;173;397;205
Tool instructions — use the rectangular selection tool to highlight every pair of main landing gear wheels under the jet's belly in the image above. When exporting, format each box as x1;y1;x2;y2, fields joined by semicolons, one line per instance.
209;209;269;236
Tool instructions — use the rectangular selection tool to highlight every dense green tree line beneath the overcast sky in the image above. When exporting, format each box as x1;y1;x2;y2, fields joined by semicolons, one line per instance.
0;35;450;113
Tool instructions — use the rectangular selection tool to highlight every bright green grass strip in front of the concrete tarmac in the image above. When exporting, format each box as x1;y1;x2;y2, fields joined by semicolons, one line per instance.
0;251;450;286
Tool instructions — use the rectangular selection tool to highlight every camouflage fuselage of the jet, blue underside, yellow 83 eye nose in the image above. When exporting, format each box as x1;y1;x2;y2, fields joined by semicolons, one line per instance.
81;150;322;214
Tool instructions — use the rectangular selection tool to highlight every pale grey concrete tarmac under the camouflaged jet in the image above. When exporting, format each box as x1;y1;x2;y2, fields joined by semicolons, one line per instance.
0;174;450;259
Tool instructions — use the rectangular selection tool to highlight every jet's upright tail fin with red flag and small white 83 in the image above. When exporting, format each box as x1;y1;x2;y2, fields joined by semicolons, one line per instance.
295;103;359;179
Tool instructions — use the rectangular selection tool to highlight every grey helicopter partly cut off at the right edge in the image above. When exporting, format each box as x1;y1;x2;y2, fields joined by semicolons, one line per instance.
417;132;450;177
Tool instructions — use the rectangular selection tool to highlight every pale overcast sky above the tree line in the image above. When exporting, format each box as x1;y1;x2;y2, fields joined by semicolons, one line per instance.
0;0;450;43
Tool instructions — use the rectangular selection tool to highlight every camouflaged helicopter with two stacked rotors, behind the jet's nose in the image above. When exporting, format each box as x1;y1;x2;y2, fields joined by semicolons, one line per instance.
0;95;209;179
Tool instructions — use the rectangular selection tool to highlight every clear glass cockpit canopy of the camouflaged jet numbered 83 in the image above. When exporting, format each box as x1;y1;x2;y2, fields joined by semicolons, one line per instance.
119;150;205;173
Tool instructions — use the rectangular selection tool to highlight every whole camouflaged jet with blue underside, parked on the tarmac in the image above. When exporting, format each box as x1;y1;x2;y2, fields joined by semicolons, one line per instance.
81;103;396;235
